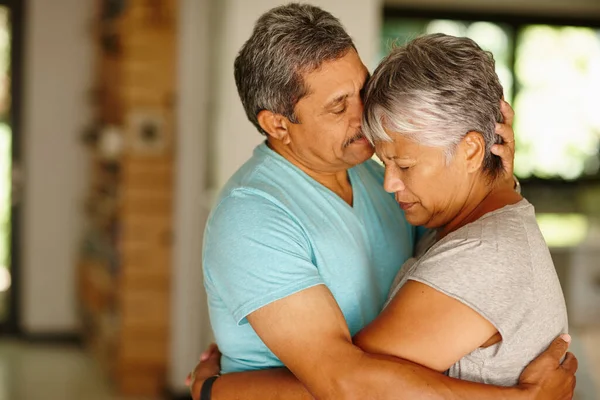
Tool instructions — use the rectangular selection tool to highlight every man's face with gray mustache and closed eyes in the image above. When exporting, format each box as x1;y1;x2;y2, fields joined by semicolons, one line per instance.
289;49;374;172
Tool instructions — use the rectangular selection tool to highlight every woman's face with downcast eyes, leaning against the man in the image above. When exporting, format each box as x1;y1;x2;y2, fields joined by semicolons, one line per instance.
375;132;473;228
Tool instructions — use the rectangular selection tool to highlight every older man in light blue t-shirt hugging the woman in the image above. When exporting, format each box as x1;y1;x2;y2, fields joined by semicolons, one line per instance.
191;4;576;399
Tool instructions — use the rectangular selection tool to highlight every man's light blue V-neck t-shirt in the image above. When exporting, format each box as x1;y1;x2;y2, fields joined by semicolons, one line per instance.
203;143;416;373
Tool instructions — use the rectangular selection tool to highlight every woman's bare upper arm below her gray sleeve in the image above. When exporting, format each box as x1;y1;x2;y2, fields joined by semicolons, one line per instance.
354;280;498;372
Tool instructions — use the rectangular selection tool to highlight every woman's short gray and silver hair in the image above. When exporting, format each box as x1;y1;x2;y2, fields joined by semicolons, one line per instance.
363;34;502;178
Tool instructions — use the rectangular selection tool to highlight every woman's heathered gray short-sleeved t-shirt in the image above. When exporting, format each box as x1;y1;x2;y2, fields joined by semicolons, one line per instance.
388;200;568;386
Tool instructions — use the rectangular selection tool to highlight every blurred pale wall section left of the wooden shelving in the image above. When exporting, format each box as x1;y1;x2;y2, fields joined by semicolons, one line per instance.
20;0;94;333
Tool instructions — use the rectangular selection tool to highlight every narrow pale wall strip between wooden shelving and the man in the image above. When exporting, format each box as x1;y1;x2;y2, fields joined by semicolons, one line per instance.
168;0;212;392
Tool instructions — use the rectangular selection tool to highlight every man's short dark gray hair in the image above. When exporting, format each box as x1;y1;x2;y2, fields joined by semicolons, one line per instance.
234;3;354;134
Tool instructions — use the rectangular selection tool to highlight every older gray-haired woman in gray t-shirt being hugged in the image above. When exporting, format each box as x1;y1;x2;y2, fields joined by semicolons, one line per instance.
355;34;567;385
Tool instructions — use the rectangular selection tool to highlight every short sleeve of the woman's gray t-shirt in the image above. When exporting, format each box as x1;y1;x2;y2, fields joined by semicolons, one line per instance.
408;239;533;337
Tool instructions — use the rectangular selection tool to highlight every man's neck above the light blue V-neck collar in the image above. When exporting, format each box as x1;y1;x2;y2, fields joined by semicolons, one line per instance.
267;140;353;206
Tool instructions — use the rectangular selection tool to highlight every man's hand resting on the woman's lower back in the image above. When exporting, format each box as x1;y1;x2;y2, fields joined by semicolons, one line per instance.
519;335;577;400
